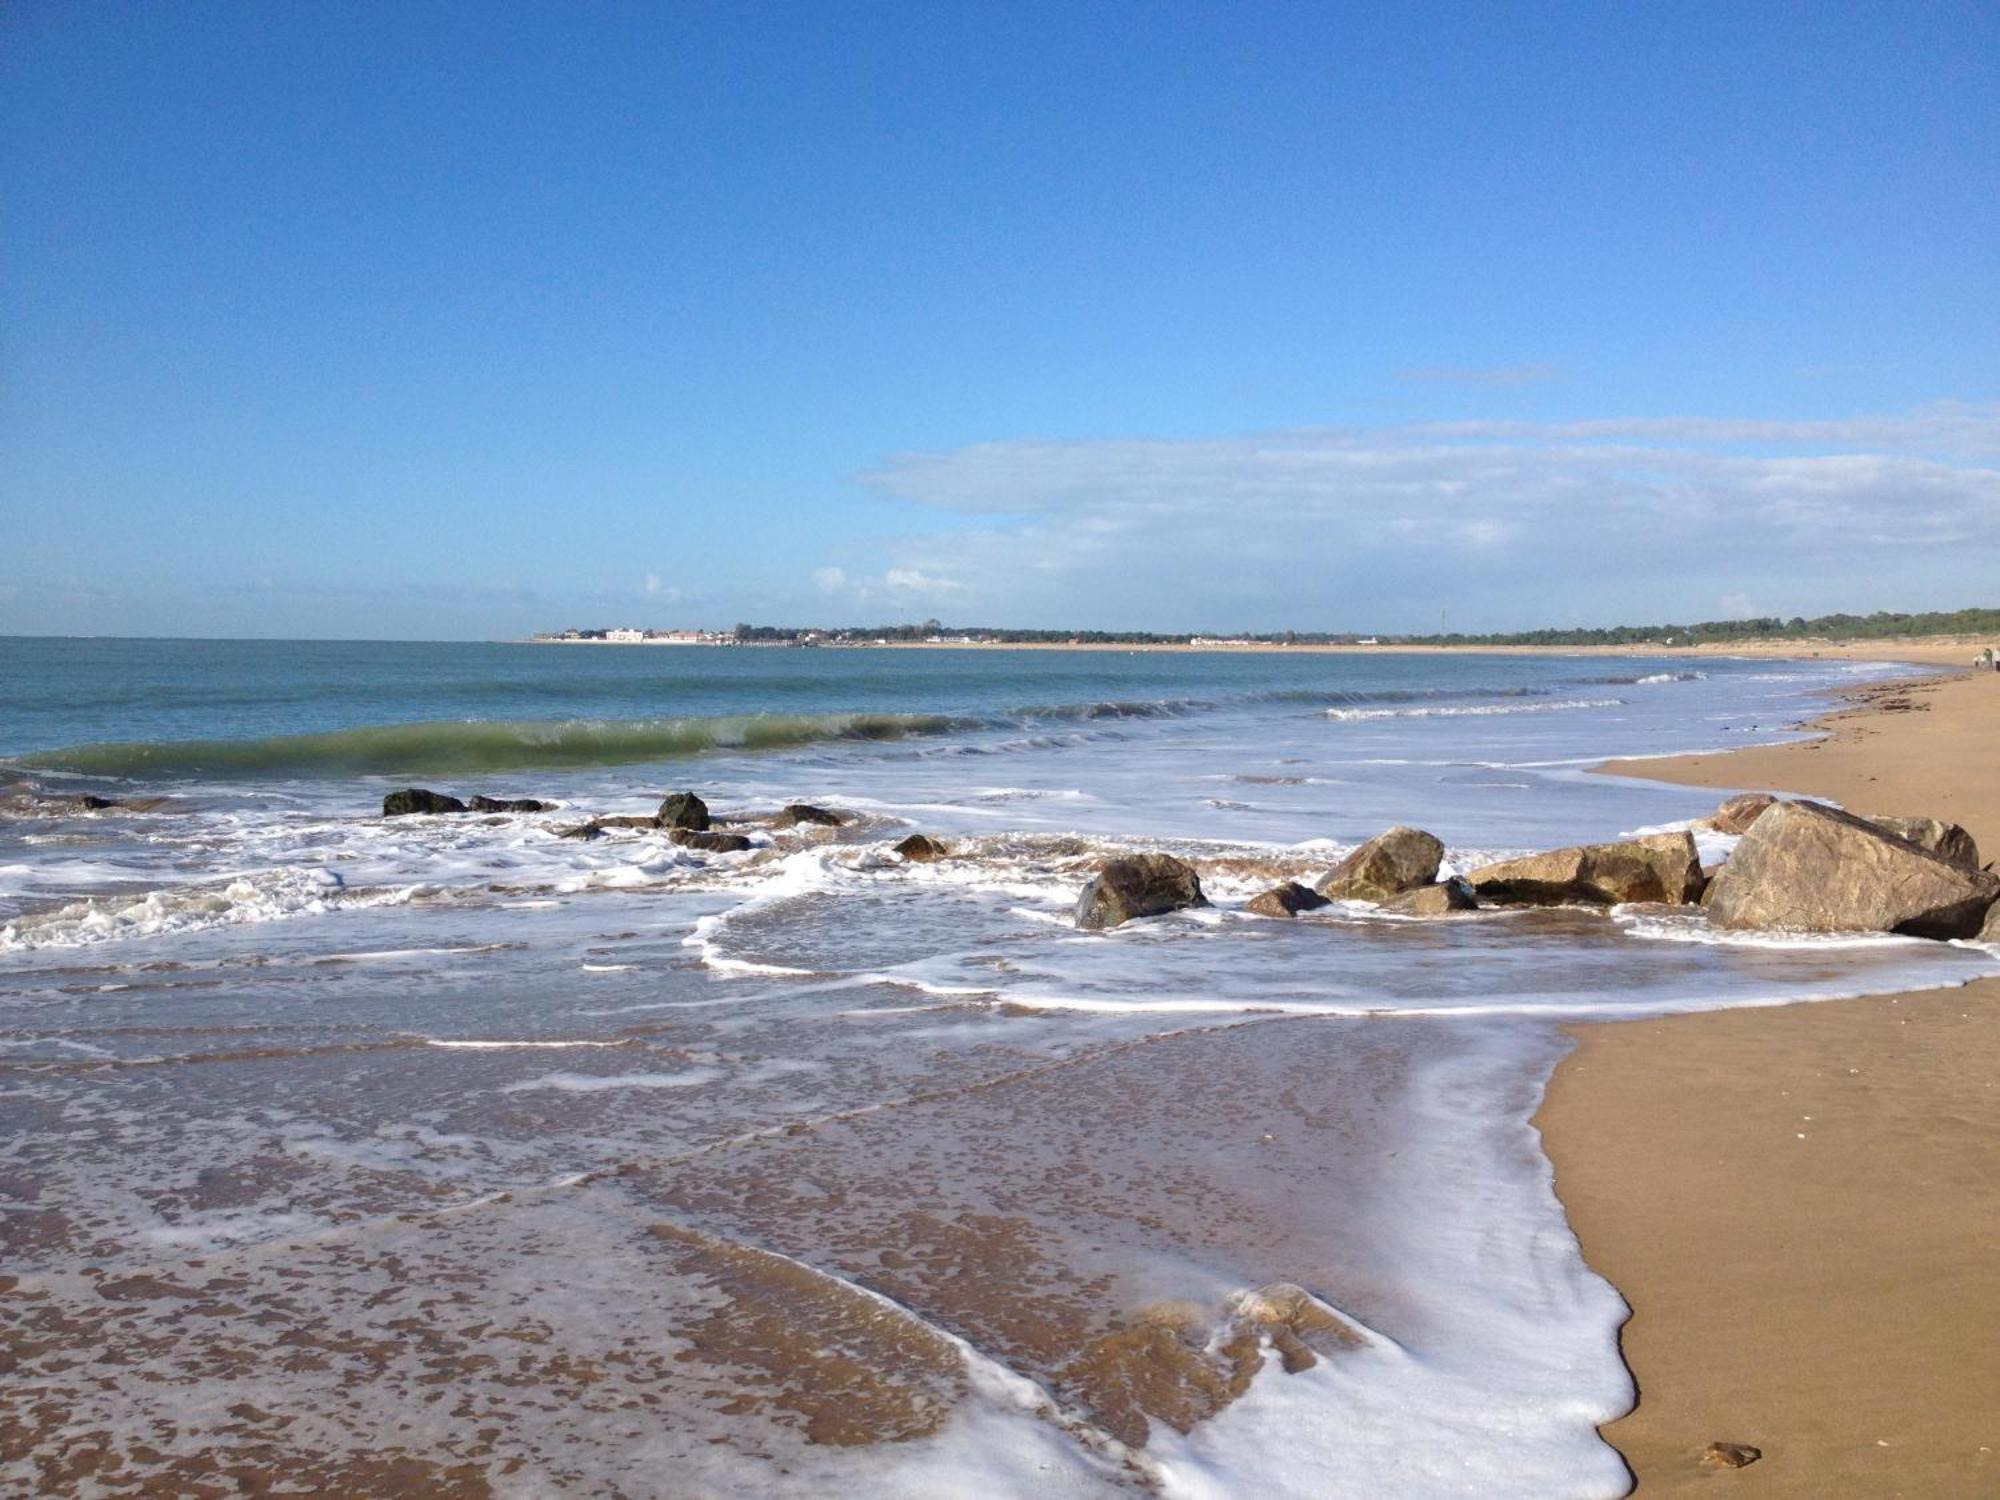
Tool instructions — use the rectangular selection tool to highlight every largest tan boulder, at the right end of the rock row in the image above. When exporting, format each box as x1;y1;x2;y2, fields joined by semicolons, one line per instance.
1708;802;2000;938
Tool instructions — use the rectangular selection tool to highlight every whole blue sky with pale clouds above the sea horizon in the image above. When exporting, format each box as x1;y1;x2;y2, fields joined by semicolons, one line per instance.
0;0;2000;638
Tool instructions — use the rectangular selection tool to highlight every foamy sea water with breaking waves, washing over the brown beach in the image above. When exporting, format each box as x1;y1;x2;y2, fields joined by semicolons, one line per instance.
0;640;1992;1496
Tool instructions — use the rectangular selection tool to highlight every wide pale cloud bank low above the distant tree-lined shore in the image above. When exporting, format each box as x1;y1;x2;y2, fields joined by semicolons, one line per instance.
850;404;2000;630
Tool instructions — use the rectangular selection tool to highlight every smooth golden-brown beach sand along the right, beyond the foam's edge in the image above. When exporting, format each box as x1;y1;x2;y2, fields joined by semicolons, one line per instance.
1538;650;2000;1500
